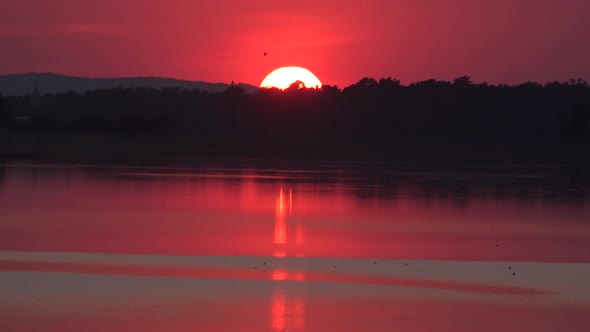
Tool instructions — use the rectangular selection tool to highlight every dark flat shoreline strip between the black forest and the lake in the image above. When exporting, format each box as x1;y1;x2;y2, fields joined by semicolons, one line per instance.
0;131;590;166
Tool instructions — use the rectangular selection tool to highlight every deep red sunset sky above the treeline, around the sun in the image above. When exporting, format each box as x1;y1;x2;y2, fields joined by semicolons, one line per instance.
0;0;590;87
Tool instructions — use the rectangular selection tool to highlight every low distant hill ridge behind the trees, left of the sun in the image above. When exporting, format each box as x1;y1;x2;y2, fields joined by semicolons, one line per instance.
0;73;258;96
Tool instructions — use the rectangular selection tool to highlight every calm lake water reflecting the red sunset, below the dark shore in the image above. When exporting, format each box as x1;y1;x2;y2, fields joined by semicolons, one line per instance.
0;161;590;332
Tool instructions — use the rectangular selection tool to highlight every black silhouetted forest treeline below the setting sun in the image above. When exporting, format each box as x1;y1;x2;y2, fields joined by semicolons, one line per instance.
0;76;590;162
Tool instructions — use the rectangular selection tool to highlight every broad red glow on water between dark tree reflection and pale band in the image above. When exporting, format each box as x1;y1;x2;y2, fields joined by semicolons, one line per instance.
0;166;590;261
